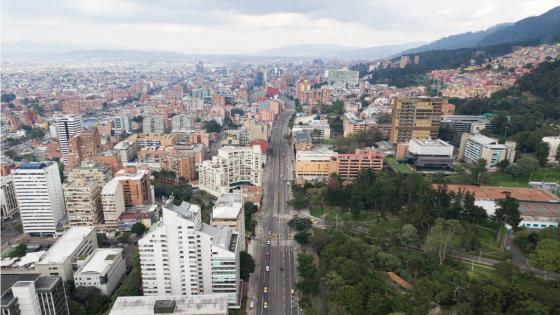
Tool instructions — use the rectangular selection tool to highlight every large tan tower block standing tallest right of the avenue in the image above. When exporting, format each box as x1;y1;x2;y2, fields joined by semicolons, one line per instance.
390;96;443;143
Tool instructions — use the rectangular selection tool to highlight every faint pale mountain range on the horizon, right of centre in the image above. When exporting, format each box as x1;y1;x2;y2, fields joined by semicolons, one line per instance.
255;42;422;59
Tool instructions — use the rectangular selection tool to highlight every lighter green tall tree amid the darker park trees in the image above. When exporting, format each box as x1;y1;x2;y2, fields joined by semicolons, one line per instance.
424;218;461;266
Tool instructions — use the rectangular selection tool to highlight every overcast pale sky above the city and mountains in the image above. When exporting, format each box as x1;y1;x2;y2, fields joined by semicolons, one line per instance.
0;0;560;54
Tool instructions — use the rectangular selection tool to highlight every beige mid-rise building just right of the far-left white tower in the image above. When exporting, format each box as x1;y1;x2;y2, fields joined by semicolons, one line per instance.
63;178;103;226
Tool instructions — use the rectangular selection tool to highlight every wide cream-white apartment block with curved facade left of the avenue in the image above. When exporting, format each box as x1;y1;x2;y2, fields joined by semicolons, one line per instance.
198;145;265;197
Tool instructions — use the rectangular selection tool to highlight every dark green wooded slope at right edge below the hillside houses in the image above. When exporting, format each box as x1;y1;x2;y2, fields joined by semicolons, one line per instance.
450;60;560;152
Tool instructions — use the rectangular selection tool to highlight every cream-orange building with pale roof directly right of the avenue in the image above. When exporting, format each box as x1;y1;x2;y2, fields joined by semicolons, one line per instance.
296;147;336;180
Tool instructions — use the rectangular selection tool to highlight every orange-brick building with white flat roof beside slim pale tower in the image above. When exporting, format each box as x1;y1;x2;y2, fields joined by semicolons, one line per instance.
114;166;154;207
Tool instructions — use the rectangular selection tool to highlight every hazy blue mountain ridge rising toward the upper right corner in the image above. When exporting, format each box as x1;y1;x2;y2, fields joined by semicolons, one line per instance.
400;7;560;55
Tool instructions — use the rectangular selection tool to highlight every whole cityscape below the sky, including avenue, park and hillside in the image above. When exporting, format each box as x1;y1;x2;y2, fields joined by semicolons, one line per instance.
0;2;560;315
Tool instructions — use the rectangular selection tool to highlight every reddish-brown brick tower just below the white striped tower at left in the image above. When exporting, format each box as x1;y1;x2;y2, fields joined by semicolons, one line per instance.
68;129;101;170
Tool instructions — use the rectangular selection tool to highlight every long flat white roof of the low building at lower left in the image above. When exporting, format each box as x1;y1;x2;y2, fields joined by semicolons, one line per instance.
37;226;95;265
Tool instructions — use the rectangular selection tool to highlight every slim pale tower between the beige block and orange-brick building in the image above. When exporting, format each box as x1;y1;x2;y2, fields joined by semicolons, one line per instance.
101;180;125;232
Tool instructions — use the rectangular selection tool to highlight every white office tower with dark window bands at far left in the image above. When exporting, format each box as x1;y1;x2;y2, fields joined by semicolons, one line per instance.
13;162;66;236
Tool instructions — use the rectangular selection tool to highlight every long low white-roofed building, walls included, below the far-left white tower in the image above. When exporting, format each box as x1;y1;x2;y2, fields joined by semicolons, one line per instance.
35;226;97;281
